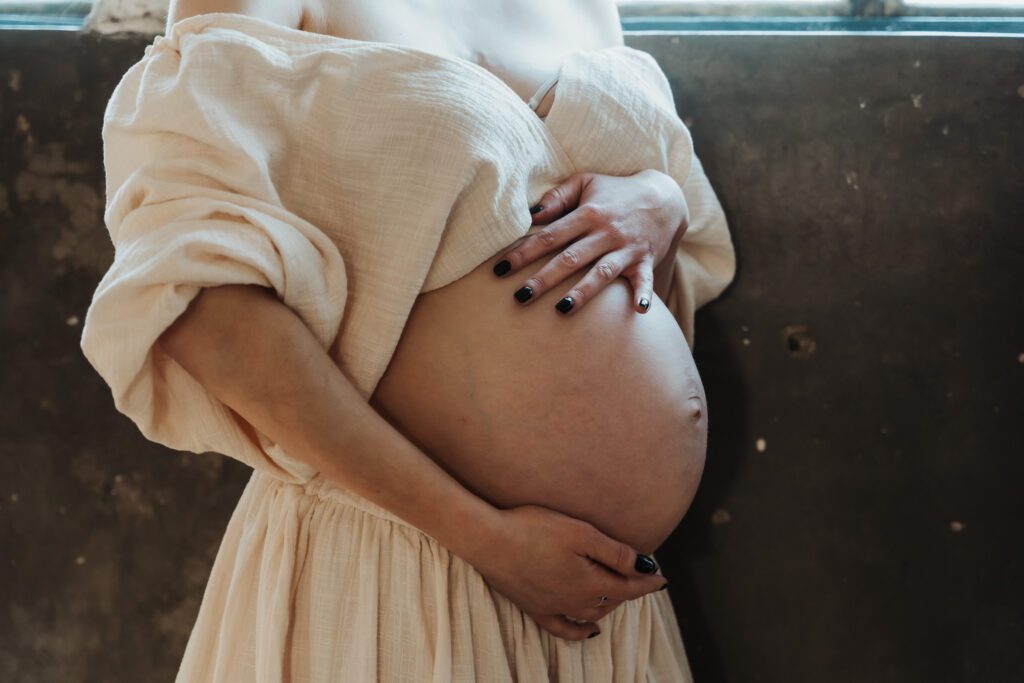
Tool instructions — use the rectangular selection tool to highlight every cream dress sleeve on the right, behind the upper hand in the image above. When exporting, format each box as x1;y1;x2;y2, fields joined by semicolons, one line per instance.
547;45;735;347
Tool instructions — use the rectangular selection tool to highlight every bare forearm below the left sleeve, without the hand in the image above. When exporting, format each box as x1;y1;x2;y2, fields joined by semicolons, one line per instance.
160;286;498;562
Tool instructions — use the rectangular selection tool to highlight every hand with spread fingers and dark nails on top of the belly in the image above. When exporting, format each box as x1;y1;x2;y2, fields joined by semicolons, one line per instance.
495;174;689;314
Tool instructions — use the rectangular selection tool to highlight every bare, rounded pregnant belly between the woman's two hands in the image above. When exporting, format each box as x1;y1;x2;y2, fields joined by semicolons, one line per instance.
370;240;708;553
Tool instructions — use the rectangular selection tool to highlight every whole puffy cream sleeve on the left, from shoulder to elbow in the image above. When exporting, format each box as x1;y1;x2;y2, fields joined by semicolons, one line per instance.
81;57;347;482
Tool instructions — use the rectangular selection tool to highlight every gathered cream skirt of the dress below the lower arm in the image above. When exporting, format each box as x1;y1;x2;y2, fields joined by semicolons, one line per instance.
176;470;692;683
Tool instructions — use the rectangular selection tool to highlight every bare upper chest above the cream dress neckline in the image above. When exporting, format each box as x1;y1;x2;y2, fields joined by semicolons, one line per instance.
303;0;623;99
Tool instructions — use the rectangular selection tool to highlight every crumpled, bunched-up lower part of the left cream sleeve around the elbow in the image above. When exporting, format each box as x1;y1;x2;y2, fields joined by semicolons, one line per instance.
81;167;347;482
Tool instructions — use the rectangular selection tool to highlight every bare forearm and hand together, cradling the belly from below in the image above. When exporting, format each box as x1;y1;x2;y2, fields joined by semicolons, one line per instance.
158;285;667;640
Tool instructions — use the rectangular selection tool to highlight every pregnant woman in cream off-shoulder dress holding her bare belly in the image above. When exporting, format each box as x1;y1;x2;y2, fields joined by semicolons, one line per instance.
82;0;734;683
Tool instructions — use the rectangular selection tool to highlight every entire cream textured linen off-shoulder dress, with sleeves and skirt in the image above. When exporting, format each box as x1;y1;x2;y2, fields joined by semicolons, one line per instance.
81;12;734;683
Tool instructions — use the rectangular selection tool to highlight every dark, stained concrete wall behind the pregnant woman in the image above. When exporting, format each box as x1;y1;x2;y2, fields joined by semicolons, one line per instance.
0;24;1024;683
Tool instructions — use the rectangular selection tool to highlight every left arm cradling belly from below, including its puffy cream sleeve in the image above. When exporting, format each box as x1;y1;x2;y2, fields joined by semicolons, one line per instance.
96;15;664;639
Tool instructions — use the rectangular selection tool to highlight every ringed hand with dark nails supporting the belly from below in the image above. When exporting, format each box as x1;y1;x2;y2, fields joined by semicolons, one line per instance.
471;505;668;640
